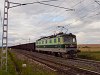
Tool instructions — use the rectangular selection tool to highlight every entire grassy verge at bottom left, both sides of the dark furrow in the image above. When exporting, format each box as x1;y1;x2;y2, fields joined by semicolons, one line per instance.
0;49;57;75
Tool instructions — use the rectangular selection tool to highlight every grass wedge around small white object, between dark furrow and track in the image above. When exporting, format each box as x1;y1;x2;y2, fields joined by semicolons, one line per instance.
13;54;55;75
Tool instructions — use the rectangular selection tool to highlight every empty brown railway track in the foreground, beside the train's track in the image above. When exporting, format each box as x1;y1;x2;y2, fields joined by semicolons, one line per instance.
12;50;100;75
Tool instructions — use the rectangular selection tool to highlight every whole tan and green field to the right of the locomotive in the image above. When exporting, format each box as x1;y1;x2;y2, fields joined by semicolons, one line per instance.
78;46;100;61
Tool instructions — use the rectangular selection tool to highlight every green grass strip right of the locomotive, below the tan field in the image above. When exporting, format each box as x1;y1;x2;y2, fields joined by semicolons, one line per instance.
78;51;100;61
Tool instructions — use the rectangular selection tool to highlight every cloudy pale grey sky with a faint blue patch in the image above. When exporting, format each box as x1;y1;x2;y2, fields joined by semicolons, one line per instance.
0;0;100;46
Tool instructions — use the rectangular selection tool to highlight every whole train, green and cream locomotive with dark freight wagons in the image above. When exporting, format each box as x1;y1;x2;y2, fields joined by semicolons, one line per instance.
11;32;79;58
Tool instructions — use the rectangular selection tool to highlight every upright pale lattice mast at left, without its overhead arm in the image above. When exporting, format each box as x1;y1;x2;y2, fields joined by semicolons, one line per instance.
1;0;9;72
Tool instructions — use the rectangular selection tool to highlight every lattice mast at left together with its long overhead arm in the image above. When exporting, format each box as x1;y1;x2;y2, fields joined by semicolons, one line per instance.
1;0;74;72
